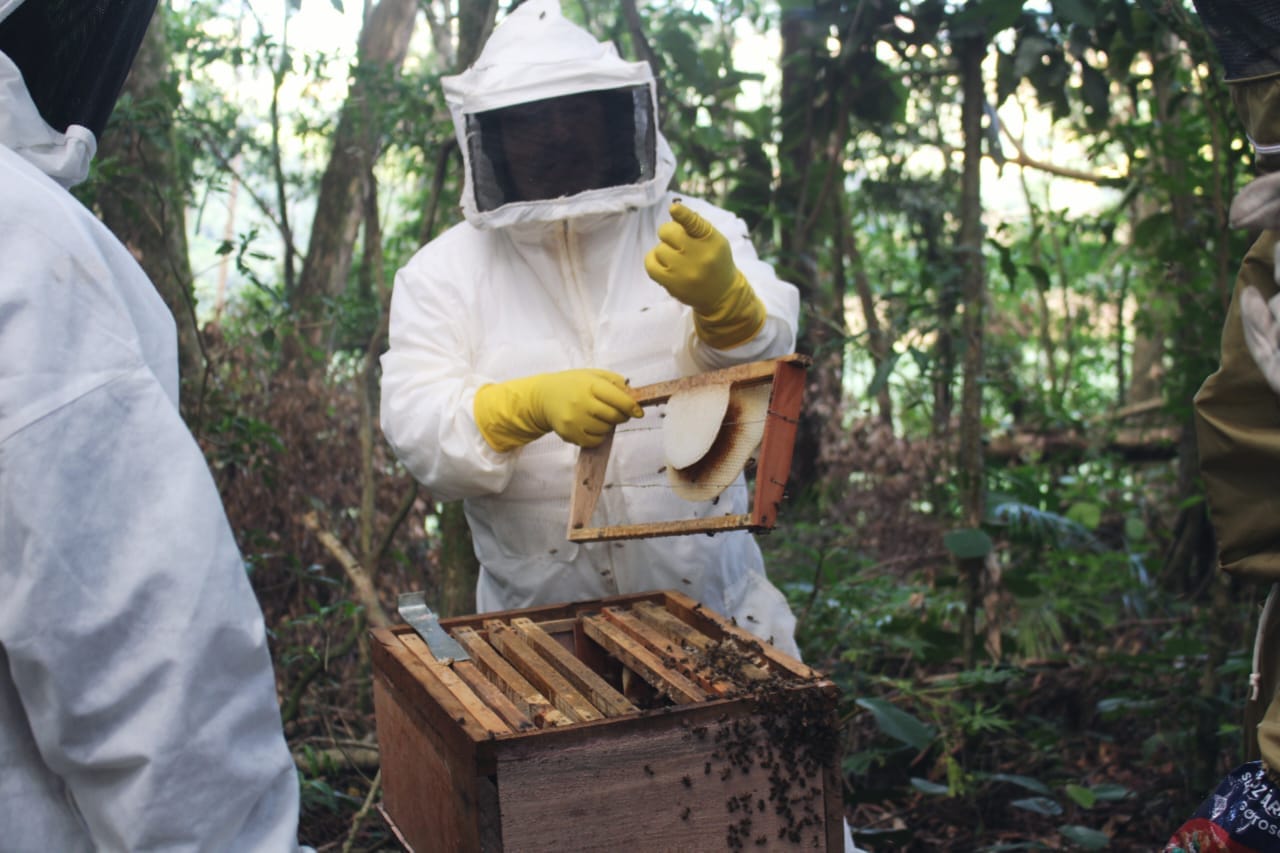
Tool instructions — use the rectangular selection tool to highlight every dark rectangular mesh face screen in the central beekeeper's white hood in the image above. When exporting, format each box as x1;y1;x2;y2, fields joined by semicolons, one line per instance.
466;85;657;211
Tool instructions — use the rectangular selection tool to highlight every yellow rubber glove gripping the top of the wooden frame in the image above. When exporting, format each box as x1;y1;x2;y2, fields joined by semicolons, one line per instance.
474;369;644;453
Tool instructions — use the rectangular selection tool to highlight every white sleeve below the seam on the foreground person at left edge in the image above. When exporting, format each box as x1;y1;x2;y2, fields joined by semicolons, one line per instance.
0;373;298;852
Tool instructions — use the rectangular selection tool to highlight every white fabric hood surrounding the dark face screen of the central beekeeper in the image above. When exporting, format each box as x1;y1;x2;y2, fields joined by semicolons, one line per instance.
443;0;676;229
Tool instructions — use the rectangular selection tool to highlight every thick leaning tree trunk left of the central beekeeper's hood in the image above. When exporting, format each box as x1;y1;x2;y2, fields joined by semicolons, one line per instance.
284;0;417;366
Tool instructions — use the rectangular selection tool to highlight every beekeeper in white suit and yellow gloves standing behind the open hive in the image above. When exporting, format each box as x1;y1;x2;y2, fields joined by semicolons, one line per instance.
381;0;799;653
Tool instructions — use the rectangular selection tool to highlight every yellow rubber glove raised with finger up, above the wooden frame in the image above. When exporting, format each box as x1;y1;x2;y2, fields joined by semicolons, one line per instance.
644;202;765;350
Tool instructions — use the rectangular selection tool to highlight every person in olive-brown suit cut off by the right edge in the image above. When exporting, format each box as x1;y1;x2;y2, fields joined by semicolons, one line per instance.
1194;0;1280;772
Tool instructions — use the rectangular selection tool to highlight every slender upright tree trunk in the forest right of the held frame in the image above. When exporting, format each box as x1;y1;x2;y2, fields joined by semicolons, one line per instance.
956;38;987;669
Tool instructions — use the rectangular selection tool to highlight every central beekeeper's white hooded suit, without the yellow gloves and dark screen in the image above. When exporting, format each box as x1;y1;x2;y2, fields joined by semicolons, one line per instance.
381;0;799;653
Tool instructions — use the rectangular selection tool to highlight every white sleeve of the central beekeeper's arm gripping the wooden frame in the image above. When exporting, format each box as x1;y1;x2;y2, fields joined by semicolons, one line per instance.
380;245;520;501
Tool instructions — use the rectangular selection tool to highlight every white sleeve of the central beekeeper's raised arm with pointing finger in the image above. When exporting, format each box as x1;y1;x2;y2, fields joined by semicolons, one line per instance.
685;199;800;370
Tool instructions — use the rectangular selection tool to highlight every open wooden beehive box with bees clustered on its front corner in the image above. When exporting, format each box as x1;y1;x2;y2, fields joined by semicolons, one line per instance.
372;592;844;853
